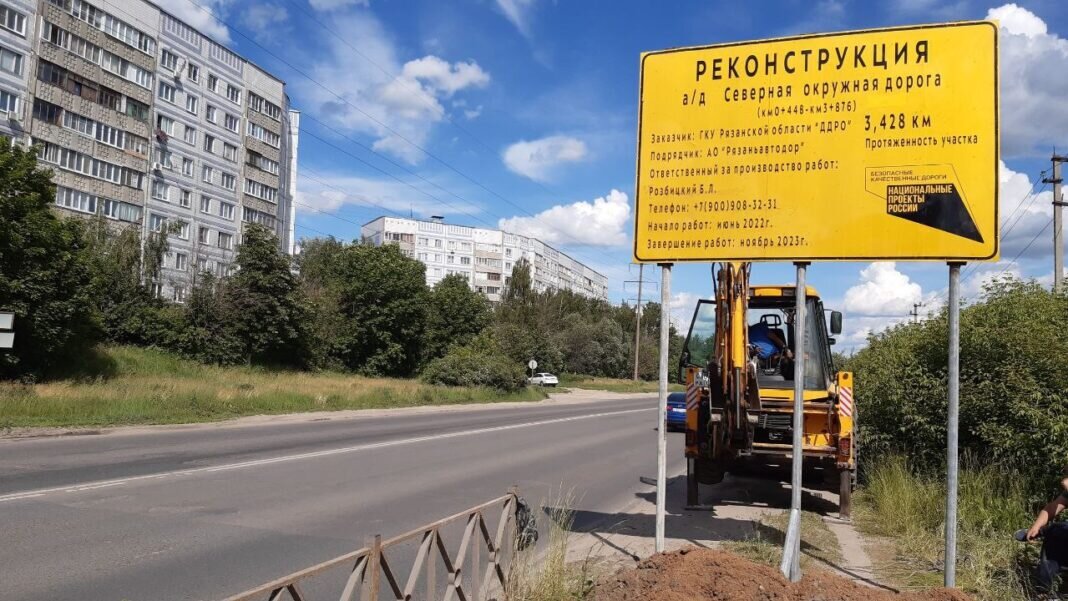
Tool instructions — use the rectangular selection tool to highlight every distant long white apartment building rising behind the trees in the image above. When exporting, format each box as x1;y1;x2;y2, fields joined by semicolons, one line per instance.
361;217;608;301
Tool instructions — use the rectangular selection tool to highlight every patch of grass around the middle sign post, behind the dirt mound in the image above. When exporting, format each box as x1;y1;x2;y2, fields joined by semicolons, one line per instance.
723;511;842;569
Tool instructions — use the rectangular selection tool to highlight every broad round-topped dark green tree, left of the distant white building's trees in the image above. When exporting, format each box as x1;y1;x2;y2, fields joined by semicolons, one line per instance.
332;244;427;376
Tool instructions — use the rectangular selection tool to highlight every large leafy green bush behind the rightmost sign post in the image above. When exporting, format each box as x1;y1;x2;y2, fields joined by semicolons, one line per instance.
848;280;1068;493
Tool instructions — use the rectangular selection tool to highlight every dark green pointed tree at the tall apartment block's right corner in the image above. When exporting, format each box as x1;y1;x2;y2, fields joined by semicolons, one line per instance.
225;224;309;367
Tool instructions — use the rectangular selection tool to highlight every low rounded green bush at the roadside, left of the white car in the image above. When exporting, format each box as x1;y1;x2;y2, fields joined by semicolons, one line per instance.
423;336;527;392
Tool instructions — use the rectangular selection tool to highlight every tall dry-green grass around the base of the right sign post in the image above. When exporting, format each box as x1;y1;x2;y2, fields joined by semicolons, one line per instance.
855;457;1034;601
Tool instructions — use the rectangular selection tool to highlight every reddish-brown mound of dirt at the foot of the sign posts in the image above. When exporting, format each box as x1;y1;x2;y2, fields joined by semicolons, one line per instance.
594;549;969;601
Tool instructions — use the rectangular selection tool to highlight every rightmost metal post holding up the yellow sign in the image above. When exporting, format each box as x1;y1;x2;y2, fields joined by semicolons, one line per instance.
945;263;963;588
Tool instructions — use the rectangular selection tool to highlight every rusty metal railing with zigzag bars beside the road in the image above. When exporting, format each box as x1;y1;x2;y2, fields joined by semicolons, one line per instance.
225;489;536;601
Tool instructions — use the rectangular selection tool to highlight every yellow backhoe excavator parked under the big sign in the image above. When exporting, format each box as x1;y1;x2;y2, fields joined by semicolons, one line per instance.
679;263;857;518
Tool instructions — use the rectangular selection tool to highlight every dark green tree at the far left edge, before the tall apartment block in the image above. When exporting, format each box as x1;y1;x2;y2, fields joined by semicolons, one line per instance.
0;139;99;376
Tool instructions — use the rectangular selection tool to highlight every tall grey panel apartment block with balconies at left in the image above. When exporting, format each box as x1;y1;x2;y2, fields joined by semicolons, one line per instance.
0;0;299;302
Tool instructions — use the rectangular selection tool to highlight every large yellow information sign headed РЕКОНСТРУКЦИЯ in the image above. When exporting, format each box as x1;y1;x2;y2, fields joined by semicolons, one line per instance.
634;21;999;263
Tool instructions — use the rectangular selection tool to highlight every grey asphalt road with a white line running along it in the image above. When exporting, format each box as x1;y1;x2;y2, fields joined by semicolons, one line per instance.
0;396;684;601
